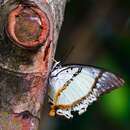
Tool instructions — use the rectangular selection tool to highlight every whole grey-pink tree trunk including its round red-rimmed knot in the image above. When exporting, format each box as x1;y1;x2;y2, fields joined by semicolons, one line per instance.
0;0;66;130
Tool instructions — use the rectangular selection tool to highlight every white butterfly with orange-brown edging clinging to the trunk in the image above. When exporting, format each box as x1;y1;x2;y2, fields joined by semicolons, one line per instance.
48;62;124;119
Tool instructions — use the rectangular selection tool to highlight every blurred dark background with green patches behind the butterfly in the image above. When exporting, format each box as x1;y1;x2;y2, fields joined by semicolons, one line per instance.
42;0;130;130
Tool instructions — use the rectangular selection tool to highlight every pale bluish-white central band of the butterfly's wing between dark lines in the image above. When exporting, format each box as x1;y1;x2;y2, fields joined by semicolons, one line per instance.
57;69;98;106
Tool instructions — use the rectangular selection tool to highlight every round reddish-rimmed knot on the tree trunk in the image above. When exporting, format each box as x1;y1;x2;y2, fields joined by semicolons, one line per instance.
6;5;49;48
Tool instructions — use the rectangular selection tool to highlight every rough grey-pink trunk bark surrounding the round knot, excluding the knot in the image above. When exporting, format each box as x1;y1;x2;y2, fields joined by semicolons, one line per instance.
0;0;66;130
